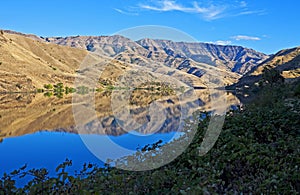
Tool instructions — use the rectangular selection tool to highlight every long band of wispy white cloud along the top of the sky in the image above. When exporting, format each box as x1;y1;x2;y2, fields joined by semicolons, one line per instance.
114;0;266;21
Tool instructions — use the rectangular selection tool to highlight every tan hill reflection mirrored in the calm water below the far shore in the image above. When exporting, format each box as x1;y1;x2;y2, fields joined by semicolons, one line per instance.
0;90;240;139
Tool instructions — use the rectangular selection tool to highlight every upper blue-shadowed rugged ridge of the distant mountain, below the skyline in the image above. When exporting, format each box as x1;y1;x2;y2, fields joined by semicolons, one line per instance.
45;35;269;74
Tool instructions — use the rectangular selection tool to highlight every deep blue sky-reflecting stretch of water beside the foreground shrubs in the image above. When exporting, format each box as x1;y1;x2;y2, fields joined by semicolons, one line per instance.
0;132;177;175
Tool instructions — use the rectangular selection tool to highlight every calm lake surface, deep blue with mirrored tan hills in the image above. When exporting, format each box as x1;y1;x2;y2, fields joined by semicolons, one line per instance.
0;91;239;181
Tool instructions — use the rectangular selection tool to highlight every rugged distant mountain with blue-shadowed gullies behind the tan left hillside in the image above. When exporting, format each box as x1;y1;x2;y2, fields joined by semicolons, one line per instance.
44;35;269;87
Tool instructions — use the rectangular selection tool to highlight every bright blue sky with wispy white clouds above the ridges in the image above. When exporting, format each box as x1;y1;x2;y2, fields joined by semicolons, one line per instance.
0;0;300;54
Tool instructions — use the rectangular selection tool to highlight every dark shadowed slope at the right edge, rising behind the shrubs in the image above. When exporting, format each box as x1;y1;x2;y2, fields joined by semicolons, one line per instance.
234;47;300;87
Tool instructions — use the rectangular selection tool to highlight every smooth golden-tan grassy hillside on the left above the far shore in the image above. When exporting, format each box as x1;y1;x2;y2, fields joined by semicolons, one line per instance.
0;31;88;92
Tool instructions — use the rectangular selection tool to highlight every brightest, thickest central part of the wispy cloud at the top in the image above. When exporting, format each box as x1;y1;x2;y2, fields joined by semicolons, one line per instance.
139;0;226;20
